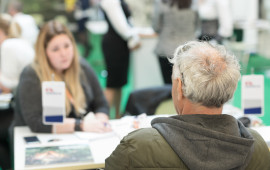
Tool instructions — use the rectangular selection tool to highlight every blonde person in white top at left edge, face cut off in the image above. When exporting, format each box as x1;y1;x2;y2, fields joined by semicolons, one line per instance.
0;14;35;93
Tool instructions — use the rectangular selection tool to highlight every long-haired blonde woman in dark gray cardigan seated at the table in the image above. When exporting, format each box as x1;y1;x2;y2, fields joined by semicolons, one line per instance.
11;21;110;133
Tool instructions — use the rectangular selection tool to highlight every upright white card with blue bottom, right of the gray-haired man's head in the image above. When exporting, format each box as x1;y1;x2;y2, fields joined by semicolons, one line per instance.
242;75;264;116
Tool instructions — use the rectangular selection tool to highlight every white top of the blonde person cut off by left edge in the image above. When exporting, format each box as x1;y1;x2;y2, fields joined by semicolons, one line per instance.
0;38;35;89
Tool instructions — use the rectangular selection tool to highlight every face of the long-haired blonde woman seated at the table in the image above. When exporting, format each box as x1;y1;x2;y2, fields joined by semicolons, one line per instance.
46;34;74;73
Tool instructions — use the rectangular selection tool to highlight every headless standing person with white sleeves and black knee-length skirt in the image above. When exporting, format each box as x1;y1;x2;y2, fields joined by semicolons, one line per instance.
101;0;140;118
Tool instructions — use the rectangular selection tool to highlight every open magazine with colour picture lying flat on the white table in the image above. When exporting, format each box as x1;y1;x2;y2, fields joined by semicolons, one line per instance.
25;144;94;166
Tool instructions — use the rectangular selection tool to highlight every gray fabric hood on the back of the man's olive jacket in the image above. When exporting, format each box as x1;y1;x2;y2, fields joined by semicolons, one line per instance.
151;114;254;170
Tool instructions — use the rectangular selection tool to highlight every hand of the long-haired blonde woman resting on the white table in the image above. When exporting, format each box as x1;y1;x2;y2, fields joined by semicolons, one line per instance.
82;113;112;133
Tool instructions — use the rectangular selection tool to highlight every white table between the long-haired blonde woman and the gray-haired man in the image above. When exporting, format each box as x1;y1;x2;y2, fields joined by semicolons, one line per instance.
14;113;270;170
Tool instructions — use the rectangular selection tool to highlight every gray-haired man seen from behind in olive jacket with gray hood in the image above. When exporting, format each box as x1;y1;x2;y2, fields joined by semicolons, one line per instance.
105;41;270;170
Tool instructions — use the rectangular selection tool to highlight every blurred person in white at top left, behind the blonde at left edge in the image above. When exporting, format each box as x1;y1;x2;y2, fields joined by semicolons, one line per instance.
8;0;39;46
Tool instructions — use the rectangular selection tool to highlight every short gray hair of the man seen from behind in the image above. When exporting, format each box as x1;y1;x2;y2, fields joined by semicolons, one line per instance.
169;41;241;107
